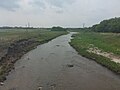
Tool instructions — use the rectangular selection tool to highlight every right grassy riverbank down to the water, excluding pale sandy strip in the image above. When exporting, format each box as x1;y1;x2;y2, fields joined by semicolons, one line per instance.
70;31;120;74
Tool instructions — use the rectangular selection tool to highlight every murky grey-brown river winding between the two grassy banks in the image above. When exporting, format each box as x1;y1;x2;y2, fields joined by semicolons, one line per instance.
0;33;120;90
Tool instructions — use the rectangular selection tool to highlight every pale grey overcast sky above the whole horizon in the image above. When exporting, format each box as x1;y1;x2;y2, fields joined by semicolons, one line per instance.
0;0;120;27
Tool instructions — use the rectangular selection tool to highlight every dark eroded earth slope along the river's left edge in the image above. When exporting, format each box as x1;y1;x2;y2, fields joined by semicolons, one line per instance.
0;39;39;82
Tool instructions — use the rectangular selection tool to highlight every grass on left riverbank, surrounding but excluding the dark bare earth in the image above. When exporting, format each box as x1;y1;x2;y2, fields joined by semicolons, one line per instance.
0;29;67;81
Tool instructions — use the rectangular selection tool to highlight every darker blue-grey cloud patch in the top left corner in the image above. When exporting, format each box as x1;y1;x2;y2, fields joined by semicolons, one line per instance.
0;0;19;11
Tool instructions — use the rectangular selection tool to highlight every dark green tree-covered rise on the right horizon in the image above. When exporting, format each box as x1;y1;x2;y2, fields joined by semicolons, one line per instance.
91;17;120;33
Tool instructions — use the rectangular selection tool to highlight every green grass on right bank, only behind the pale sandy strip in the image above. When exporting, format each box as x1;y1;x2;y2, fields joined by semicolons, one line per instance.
71;32;120;55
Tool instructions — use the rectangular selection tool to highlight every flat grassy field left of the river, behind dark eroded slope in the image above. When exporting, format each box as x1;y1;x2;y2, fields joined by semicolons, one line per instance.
0;29;65;48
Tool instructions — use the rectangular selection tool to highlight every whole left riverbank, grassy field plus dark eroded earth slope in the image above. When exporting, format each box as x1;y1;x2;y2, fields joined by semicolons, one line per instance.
0;29;67;81
